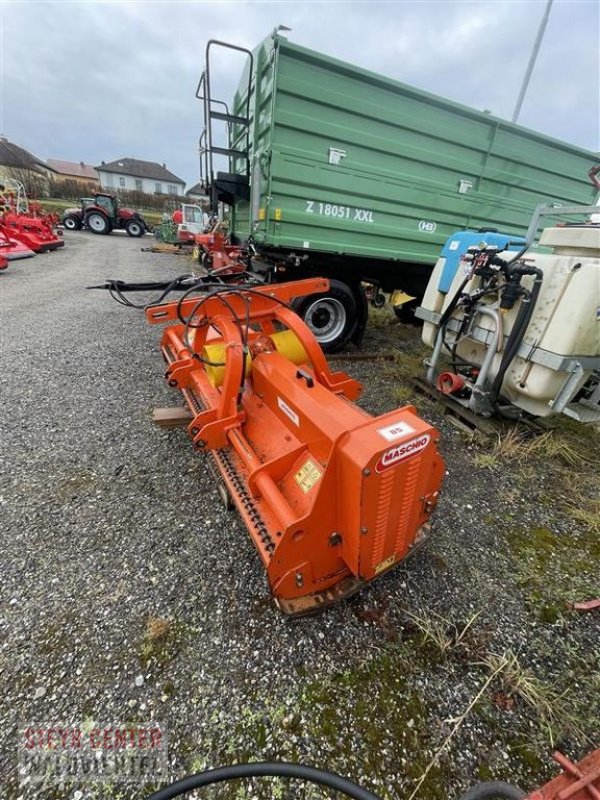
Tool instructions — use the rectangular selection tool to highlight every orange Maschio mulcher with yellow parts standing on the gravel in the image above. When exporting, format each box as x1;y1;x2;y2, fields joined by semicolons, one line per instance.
146;278;444;615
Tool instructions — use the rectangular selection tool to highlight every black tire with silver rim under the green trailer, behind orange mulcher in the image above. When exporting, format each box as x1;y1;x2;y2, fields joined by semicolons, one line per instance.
292;279;358;353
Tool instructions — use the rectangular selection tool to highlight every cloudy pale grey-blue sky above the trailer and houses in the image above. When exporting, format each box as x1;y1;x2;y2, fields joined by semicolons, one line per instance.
0;0;600;187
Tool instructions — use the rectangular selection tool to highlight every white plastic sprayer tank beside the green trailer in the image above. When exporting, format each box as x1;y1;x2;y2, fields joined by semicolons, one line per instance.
422;224;600;417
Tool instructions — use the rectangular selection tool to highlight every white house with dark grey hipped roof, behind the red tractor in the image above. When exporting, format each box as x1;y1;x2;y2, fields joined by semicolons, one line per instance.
96;158;185;196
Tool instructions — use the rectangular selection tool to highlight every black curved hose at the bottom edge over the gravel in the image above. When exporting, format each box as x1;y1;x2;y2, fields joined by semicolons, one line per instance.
148;761;381;800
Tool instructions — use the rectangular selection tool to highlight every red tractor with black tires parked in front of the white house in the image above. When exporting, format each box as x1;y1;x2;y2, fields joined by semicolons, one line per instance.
62;192;150;237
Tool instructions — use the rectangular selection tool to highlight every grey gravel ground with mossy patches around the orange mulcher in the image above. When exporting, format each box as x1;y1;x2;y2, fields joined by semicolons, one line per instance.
0;233;600;800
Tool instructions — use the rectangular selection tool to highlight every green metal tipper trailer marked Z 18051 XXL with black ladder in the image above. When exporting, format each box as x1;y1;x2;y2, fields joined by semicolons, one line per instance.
198;32;598;349
